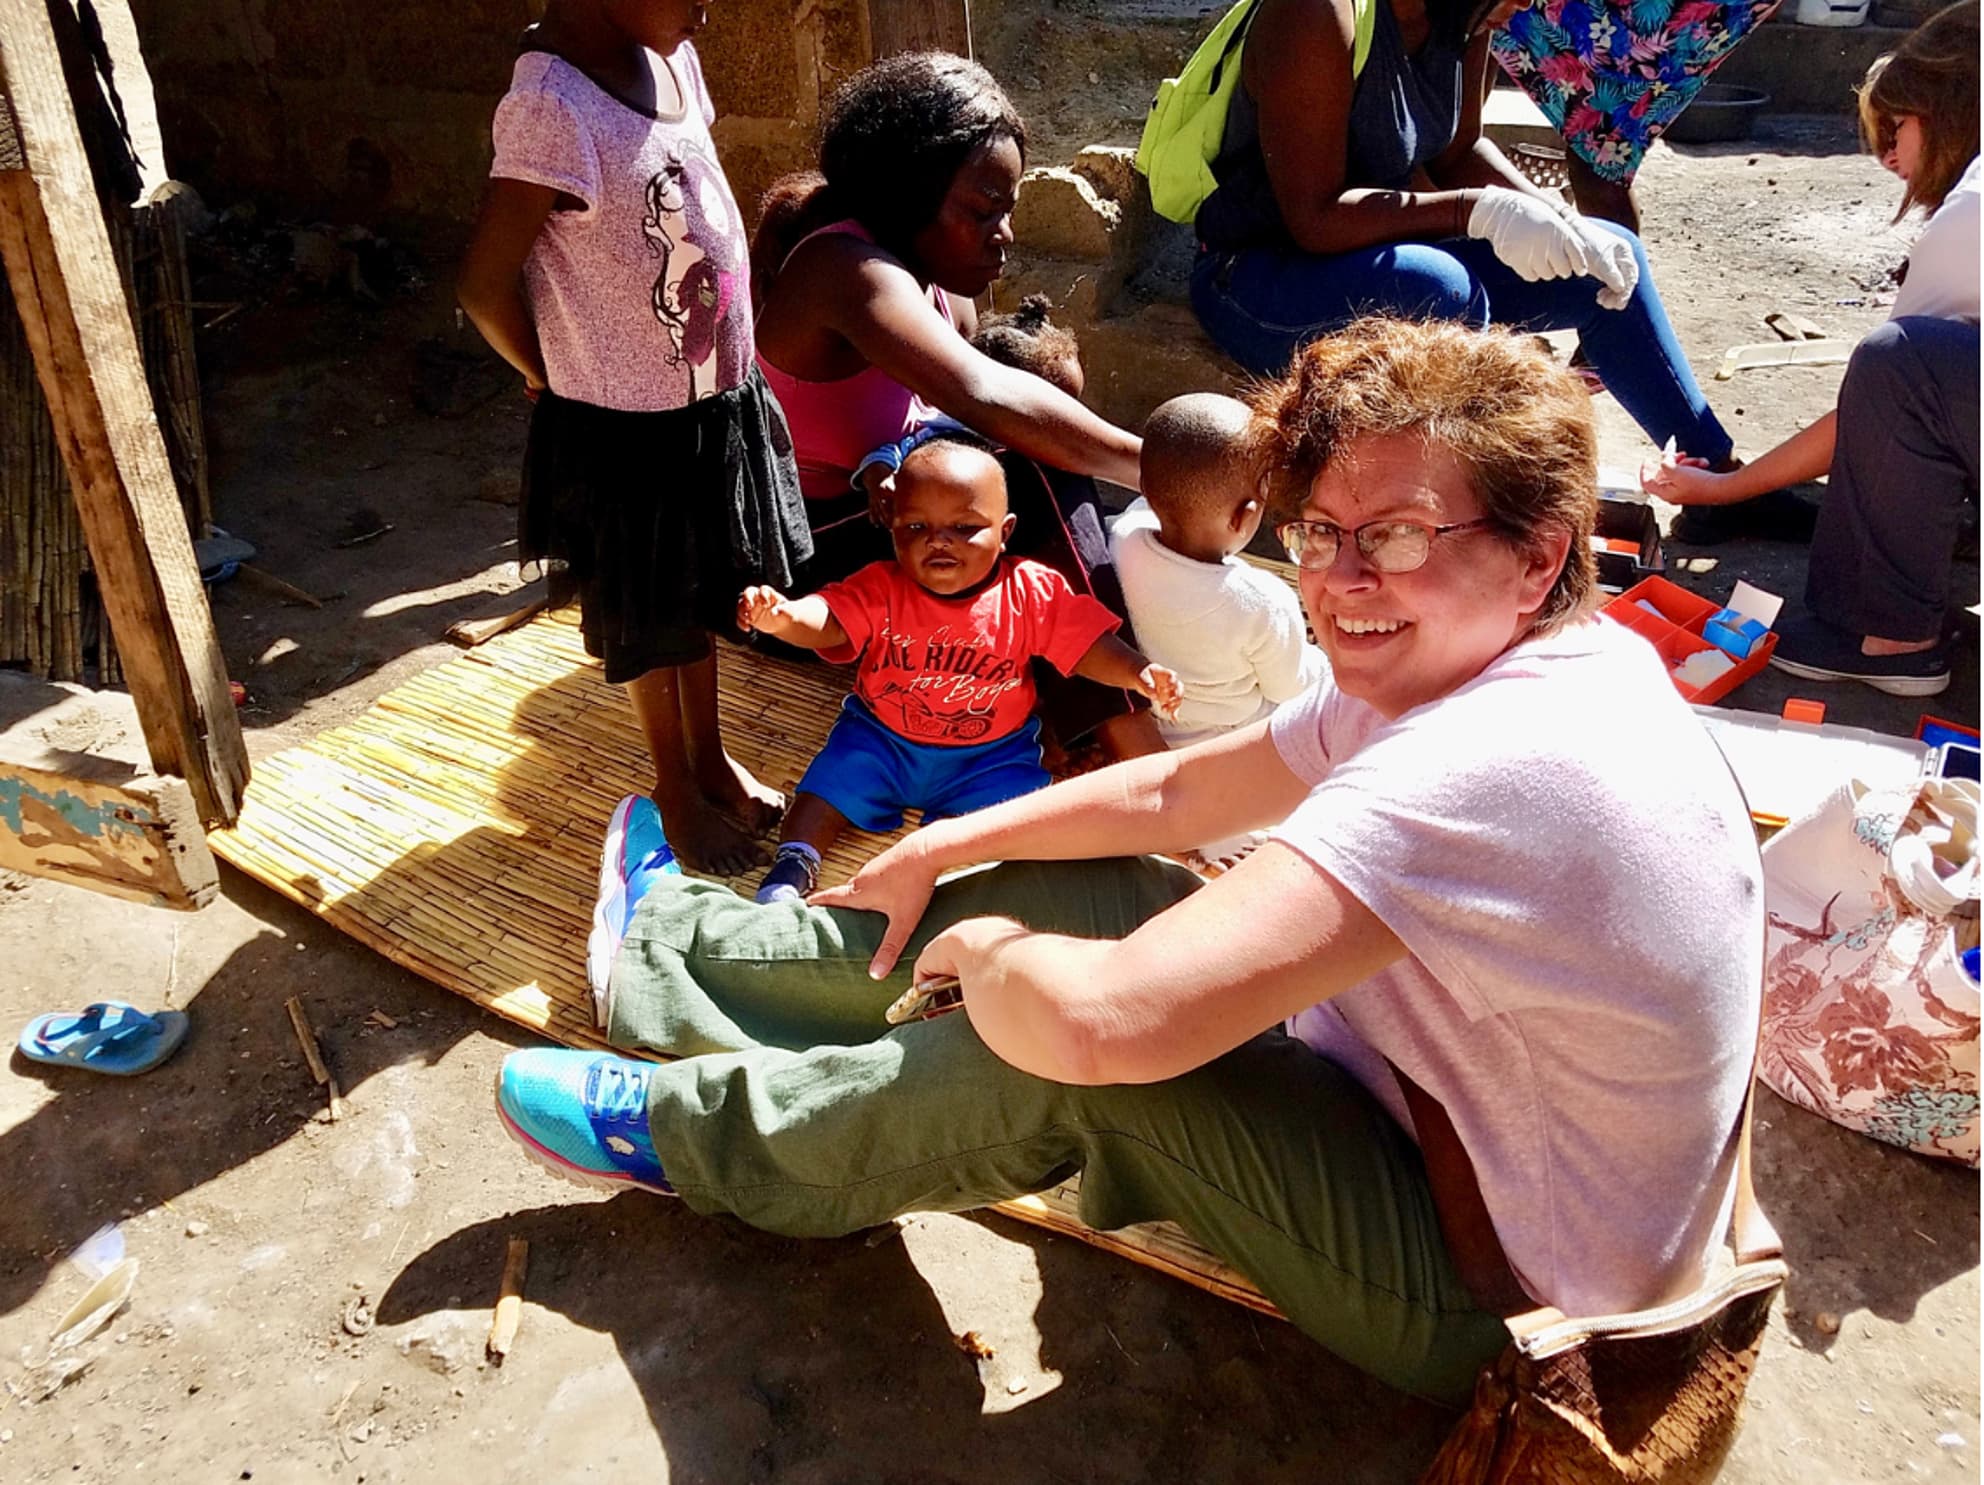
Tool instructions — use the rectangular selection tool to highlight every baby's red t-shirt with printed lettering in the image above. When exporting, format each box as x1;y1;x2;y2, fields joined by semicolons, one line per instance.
819;558;1123;746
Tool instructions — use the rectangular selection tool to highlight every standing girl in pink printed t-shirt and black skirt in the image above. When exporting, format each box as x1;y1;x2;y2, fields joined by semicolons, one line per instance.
460;0;811;876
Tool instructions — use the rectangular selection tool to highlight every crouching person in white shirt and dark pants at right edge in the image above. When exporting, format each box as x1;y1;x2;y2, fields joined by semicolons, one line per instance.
1645;0;1980;697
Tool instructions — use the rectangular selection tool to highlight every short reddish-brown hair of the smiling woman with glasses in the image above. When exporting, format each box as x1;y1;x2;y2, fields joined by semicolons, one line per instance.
1248;318;1599;633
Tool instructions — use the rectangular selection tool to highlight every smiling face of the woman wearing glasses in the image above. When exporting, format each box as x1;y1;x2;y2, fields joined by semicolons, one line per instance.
1300;435;1569;717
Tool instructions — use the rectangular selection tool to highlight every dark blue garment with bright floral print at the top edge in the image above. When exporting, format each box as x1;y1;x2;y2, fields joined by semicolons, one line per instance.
1492;0;1782;185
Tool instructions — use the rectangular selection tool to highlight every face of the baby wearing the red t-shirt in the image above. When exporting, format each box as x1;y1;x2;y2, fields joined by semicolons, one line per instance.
889;443;1014;598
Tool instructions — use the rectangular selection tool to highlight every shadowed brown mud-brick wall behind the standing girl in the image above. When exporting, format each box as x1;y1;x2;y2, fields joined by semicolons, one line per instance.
133;0;871;236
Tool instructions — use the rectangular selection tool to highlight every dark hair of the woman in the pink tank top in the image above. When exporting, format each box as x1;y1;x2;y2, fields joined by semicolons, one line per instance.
752;52;1026;284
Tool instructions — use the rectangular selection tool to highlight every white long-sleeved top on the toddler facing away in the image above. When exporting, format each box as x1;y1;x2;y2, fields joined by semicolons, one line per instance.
1109;498;1329;748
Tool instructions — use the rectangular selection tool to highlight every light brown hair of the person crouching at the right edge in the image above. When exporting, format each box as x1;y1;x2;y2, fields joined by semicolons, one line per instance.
1859;0;1978;222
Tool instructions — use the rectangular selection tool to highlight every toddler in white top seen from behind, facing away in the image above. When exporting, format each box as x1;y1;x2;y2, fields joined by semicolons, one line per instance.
1109;393;1329;862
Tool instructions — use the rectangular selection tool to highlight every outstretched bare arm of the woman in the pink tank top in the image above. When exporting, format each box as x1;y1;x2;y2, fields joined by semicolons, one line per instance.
809;238;1143;488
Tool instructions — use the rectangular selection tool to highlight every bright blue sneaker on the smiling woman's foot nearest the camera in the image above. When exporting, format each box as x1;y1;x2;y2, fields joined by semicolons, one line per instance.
496;1046;675;1197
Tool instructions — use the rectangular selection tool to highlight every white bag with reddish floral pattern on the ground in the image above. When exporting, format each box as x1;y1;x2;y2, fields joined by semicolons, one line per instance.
1758;778;1978;1165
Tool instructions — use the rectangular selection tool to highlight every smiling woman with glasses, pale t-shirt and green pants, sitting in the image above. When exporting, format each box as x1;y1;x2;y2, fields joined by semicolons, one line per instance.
496;320;1764;1406
